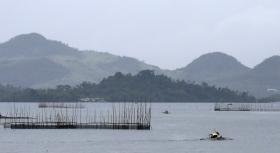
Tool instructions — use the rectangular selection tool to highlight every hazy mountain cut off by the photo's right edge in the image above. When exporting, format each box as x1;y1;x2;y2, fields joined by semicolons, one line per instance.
224;56;280;97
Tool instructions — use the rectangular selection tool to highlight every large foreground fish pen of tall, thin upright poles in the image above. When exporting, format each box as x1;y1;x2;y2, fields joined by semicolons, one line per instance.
2;102;151;130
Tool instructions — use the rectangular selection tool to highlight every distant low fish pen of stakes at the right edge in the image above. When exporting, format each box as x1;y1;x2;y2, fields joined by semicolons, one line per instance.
214;103;280;111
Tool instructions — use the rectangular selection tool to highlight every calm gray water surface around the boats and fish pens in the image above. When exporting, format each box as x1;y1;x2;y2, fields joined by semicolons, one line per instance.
0;103;280;153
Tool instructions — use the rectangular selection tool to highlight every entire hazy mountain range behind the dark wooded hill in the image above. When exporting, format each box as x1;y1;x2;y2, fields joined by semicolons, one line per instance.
0;33;280;97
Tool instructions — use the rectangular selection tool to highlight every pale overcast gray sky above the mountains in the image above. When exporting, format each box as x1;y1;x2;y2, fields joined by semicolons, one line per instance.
0;0;280;69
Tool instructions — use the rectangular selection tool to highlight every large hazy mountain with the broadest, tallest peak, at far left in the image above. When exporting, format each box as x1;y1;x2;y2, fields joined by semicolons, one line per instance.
0;33;159;87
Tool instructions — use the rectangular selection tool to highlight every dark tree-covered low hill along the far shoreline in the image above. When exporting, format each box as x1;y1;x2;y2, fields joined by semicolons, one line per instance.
0;70;255;102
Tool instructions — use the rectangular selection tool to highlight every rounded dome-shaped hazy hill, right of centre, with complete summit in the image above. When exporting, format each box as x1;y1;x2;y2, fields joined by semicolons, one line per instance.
174;52;250;83
